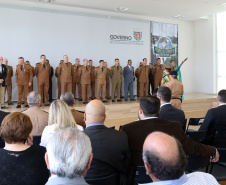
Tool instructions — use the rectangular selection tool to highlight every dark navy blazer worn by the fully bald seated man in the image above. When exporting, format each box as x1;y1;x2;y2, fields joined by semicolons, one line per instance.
84;125;130;185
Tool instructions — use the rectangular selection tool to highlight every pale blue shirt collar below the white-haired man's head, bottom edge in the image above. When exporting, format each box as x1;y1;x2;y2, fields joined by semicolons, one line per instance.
46;176;88;185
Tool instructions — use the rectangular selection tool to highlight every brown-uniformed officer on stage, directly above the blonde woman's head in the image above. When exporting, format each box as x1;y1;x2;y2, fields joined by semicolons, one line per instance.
57;55;72;94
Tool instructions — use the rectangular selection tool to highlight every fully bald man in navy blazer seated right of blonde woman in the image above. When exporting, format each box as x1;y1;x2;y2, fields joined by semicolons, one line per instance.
84;100;130;185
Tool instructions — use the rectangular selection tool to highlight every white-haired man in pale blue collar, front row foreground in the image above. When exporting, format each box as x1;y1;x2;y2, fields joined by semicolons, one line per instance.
45;127;93;185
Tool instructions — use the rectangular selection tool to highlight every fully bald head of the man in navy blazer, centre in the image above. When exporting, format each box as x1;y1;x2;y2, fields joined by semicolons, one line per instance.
84;100;106;126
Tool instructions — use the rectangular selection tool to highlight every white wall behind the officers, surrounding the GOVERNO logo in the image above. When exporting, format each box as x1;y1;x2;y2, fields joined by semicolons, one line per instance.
0;8;194;100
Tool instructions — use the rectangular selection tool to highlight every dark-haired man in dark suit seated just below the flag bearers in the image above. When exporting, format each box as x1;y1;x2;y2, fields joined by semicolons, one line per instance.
157;86;186;129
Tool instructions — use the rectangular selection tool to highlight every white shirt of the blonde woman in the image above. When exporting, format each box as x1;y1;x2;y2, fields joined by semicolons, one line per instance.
40;124;83;147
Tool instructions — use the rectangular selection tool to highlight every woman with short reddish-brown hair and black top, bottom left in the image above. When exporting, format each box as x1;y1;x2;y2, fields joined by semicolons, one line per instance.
0;112;49;185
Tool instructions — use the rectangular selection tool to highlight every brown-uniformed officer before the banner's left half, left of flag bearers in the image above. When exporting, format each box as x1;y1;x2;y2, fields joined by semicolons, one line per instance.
152;58;164;89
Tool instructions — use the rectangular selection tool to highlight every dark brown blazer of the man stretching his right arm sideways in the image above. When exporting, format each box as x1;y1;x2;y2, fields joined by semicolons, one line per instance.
121;118;216;184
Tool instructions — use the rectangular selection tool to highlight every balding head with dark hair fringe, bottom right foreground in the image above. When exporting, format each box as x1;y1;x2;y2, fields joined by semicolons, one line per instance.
143;132;187;182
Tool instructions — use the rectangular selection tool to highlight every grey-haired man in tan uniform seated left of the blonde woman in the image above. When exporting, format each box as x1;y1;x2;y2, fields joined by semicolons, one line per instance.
23;91;49;136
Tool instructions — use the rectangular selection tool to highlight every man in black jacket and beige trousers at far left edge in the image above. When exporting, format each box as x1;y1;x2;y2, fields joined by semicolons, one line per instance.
0;57;8;109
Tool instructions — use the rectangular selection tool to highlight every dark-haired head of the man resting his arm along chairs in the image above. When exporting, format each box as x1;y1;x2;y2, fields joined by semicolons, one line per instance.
139;96;160;119
